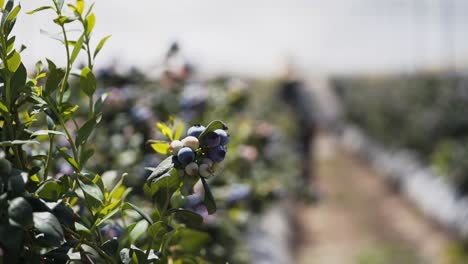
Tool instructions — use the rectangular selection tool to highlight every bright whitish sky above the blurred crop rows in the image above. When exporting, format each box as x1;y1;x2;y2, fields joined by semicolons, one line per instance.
12;0;468;74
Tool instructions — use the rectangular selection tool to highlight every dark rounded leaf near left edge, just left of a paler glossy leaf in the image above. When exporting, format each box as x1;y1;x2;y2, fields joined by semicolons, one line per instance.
8;197;33;229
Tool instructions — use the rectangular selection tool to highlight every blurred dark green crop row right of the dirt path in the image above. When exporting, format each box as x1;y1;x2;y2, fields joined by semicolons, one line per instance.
333;73;468;196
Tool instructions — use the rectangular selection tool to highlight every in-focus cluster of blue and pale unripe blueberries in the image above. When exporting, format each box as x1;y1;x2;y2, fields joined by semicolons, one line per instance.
169;125;229;178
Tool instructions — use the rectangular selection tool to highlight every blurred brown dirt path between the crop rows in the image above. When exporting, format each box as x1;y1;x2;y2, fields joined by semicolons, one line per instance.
296;134;453;264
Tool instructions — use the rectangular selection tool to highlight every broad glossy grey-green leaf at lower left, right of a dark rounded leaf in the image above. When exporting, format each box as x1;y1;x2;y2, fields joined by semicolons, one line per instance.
33;212;64;247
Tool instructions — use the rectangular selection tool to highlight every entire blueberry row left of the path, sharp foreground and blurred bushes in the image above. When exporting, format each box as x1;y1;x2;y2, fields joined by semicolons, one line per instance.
0;0;305;263
